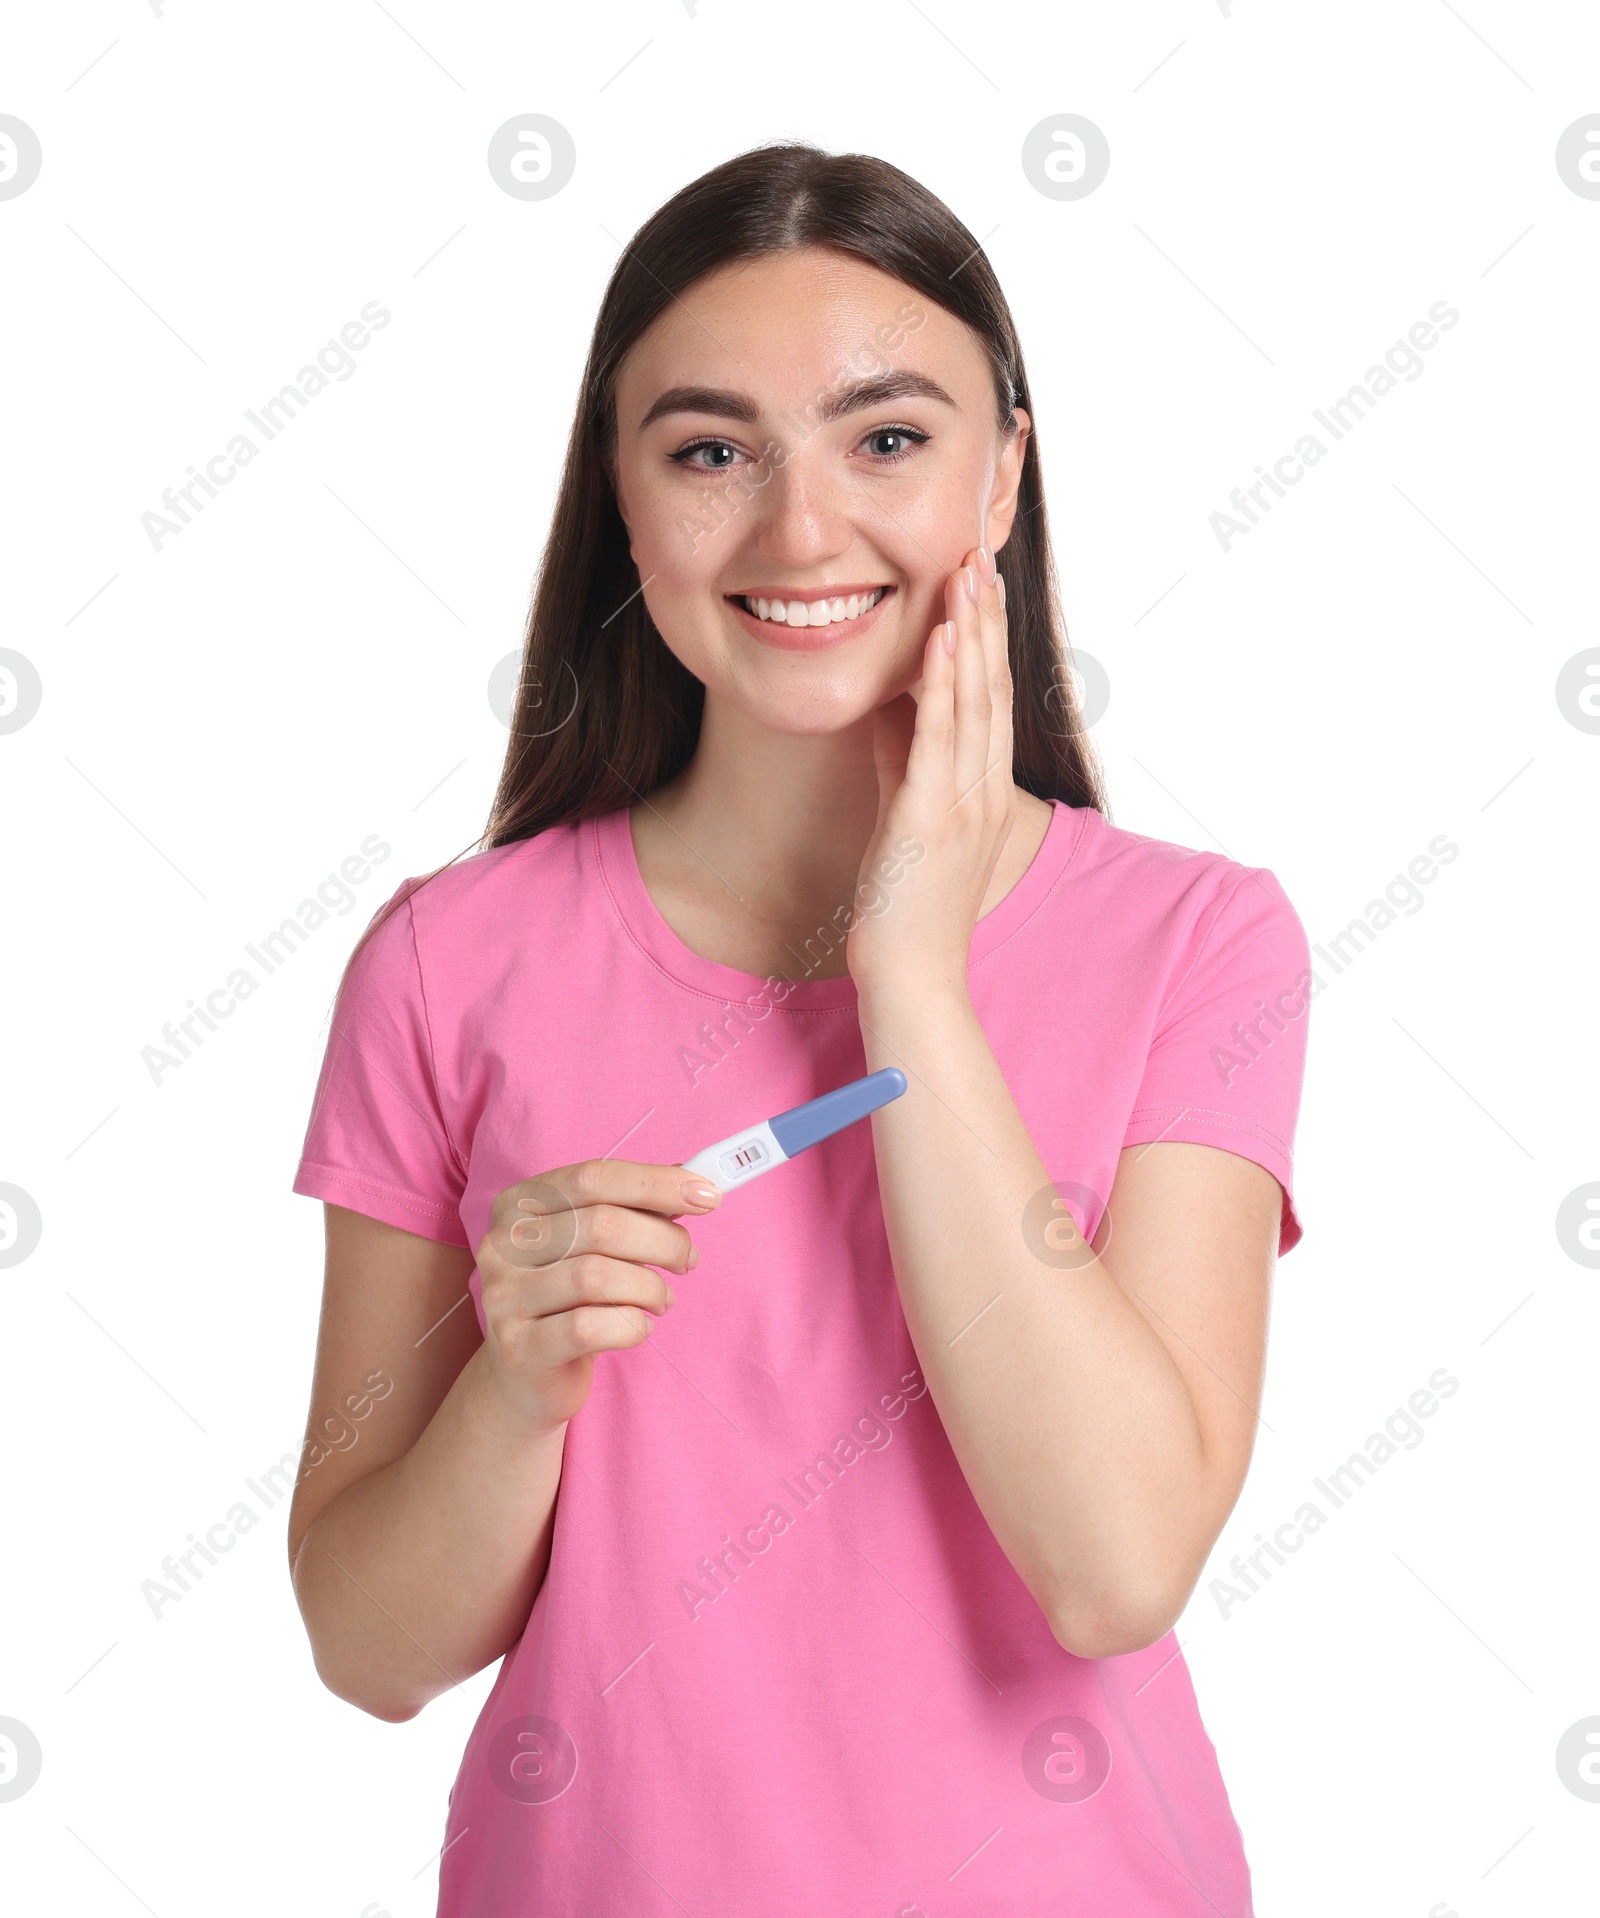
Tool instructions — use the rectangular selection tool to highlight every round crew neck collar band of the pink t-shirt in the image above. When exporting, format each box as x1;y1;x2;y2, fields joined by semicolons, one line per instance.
583;800;1088;1013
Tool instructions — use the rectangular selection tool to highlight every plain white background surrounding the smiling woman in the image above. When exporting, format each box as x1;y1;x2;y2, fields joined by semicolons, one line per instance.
0;0;1600;1918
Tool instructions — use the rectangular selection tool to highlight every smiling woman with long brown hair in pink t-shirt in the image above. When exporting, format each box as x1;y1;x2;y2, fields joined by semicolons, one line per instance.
290;146;1310;1918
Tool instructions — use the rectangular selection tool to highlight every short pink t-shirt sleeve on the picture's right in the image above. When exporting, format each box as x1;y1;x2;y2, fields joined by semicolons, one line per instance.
1122;867;1318;1254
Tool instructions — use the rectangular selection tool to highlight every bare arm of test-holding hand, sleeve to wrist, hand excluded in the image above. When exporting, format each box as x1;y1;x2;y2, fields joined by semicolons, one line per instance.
290;1205;564;1719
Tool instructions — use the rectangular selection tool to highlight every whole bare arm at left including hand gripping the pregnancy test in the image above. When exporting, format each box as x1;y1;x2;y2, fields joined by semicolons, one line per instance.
290;1160;709;1720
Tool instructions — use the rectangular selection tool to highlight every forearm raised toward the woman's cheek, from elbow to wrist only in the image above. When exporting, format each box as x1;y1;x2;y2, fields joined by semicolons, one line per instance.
859;986;1212;1655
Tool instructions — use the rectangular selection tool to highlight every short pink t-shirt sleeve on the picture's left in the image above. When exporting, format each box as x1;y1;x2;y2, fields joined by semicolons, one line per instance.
294;878;470;1249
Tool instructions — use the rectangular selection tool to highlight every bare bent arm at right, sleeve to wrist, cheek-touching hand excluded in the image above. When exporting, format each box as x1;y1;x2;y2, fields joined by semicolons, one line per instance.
863;999;1282;1657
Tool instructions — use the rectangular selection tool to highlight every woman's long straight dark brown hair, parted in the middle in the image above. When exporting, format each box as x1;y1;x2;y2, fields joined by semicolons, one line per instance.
345;140;1107;972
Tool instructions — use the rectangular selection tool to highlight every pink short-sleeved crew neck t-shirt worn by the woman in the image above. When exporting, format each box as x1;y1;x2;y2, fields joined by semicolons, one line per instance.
294;802;1316;1918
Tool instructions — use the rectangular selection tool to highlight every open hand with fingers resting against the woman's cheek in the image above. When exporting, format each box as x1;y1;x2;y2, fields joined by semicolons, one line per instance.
846;547;1017;992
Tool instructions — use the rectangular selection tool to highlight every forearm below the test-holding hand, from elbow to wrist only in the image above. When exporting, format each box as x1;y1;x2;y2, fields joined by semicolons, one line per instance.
294;1346;566;1719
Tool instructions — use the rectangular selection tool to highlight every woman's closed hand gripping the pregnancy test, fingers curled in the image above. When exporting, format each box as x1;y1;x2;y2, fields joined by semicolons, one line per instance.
478;1158;721;1433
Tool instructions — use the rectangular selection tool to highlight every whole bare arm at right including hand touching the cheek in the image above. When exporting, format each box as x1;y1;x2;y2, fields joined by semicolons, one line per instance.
848;544;1282;1657
